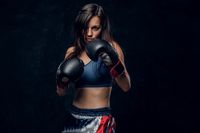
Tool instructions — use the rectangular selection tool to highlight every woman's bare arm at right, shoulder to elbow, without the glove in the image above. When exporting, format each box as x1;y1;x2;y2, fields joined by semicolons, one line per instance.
113;43;131;92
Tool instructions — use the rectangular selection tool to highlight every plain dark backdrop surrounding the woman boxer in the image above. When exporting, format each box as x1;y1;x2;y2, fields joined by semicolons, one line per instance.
0;0;200;133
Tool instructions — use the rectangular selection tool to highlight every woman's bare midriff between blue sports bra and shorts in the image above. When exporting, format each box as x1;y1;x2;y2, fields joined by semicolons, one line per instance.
73;87;112;109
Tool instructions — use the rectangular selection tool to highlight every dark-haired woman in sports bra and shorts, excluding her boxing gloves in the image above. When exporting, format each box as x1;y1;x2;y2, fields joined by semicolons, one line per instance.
57;4;131;133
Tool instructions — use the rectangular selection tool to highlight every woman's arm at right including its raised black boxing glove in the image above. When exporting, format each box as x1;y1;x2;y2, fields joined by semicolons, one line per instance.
86;39;131;91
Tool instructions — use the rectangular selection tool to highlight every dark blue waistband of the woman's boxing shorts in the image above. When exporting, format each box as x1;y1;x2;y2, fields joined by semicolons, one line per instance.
69;105;111;116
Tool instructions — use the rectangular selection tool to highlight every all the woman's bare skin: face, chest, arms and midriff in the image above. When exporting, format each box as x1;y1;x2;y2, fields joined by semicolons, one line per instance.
57;16;131;109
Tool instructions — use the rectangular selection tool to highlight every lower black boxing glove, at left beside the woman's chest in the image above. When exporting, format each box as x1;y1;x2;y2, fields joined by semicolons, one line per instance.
56;57;84;89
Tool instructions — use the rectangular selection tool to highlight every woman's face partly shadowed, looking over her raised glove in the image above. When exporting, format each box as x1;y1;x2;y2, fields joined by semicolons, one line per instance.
84;16;101;43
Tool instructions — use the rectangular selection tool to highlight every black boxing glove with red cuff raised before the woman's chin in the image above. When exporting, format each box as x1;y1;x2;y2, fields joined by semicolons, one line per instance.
86;39;124;77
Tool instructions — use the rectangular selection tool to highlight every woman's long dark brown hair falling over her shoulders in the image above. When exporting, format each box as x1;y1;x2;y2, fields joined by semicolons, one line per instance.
68;3;113;58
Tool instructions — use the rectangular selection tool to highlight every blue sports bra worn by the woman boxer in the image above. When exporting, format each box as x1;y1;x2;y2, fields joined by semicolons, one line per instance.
76;58;112;88
